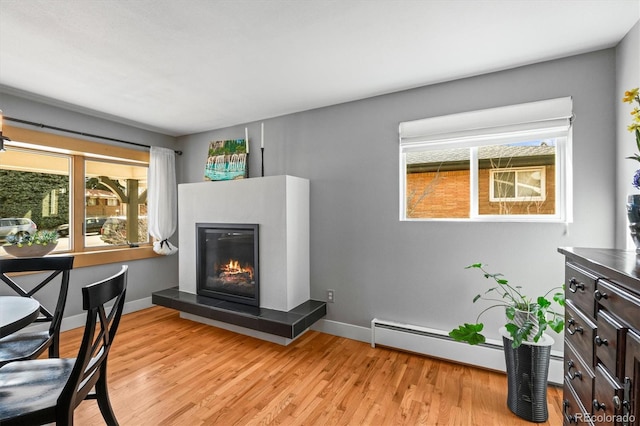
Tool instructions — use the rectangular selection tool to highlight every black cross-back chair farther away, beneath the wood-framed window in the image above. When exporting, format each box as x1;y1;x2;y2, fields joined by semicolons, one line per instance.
0;256;73;367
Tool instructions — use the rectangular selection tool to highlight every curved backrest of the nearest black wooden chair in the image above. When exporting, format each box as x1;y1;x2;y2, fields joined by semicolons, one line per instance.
58;265;128;408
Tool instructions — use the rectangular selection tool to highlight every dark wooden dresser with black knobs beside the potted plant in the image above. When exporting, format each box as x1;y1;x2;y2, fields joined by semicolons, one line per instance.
558;248;640;426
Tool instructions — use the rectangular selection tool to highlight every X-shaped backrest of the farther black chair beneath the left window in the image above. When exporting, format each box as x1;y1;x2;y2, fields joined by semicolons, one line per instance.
0;256;74;335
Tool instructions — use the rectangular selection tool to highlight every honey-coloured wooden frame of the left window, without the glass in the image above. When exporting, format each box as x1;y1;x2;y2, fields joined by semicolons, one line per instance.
0;124;159;267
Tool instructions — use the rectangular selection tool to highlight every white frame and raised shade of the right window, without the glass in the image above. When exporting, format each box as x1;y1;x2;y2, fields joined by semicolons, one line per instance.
399;97;573;223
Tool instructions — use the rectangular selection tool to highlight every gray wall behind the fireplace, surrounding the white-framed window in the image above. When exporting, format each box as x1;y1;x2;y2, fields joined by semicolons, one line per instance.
179;49;615;349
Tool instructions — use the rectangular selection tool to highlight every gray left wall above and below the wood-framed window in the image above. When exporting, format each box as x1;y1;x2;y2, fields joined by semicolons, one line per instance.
0;92;178;317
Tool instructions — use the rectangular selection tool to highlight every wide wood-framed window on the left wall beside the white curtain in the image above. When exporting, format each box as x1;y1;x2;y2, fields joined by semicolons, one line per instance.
0;126;152;266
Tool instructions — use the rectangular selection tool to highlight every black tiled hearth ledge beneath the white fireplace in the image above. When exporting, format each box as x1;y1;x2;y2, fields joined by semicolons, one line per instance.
151;287;327;339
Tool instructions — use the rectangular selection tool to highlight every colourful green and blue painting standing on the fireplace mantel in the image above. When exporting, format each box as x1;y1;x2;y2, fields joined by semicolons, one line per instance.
204;139;249;181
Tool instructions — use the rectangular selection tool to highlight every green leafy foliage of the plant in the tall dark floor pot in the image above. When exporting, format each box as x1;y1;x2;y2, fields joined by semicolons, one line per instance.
449;263;564;348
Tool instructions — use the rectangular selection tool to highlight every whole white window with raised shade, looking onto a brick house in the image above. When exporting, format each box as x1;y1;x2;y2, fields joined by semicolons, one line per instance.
400;98;572;222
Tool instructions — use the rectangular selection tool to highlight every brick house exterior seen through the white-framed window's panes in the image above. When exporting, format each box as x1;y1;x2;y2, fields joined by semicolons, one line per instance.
406;139;556;218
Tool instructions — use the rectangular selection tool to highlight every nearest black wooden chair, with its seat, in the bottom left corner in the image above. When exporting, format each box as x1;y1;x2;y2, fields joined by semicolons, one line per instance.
0;266;127;426
